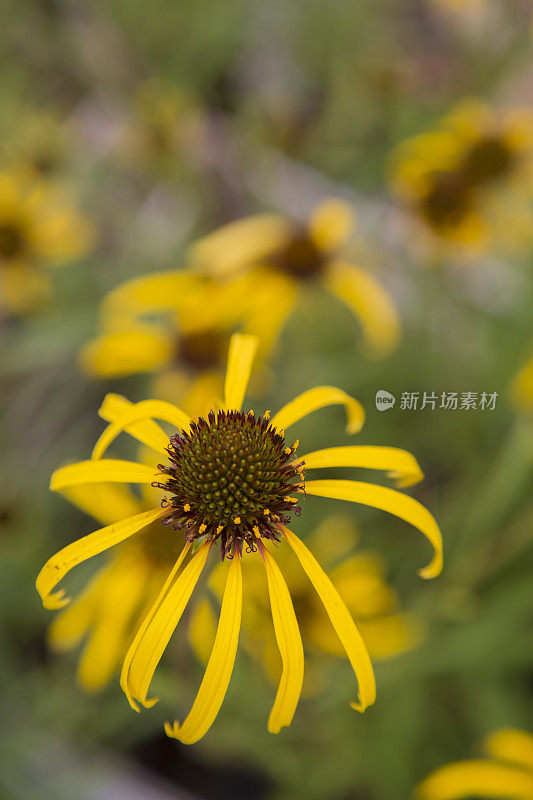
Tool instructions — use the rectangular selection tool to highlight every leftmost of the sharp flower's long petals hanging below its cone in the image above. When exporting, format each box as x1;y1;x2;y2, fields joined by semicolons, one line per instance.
121;542;211;710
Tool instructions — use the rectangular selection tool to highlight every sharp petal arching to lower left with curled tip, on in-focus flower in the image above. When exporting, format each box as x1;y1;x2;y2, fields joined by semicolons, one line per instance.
35;508;168;608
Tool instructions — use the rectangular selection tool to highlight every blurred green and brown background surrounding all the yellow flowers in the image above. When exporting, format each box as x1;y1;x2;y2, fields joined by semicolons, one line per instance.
0;0;533;800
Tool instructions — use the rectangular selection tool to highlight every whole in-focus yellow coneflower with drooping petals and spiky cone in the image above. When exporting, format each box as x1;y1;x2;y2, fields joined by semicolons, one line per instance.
37;334;442;744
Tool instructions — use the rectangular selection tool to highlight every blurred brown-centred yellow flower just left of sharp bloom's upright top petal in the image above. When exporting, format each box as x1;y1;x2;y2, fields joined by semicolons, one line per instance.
80;270;254;412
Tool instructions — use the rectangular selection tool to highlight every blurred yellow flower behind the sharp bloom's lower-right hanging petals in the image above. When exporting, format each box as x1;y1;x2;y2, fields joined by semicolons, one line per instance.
189;515;422;692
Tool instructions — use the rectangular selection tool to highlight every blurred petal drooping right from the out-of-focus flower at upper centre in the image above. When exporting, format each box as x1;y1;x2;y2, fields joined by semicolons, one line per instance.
324;261;400;358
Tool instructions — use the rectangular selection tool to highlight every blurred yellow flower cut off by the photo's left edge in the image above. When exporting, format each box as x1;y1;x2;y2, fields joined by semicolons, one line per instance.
0;171;93;313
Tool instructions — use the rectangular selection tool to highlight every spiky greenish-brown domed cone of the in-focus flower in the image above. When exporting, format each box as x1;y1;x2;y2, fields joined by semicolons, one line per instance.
154;411;304;558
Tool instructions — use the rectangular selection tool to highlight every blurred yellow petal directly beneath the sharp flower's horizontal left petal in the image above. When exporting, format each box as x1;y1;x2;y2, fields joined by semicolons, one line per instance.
61;483;142;525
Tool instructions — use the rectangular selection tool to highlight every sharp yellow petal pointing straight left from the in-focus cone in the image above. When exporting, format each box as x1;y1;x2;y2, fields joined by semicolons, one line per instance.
50;458;156;492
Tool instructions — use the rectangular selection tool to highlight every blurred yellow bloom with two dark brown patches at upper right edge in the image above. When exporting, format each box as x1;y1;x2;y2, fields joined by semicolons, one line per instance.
390;99;533;250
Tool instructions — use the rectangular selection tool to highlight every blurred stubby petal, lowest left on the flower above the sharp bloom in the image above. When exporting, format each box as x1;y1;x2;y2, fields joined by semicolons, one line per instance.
79;326;172;378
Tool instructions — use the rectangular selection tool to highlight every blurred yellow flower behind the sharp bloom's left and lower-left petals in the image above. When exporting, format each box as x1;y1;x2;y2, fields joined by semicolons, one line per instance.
48;444;181;693
